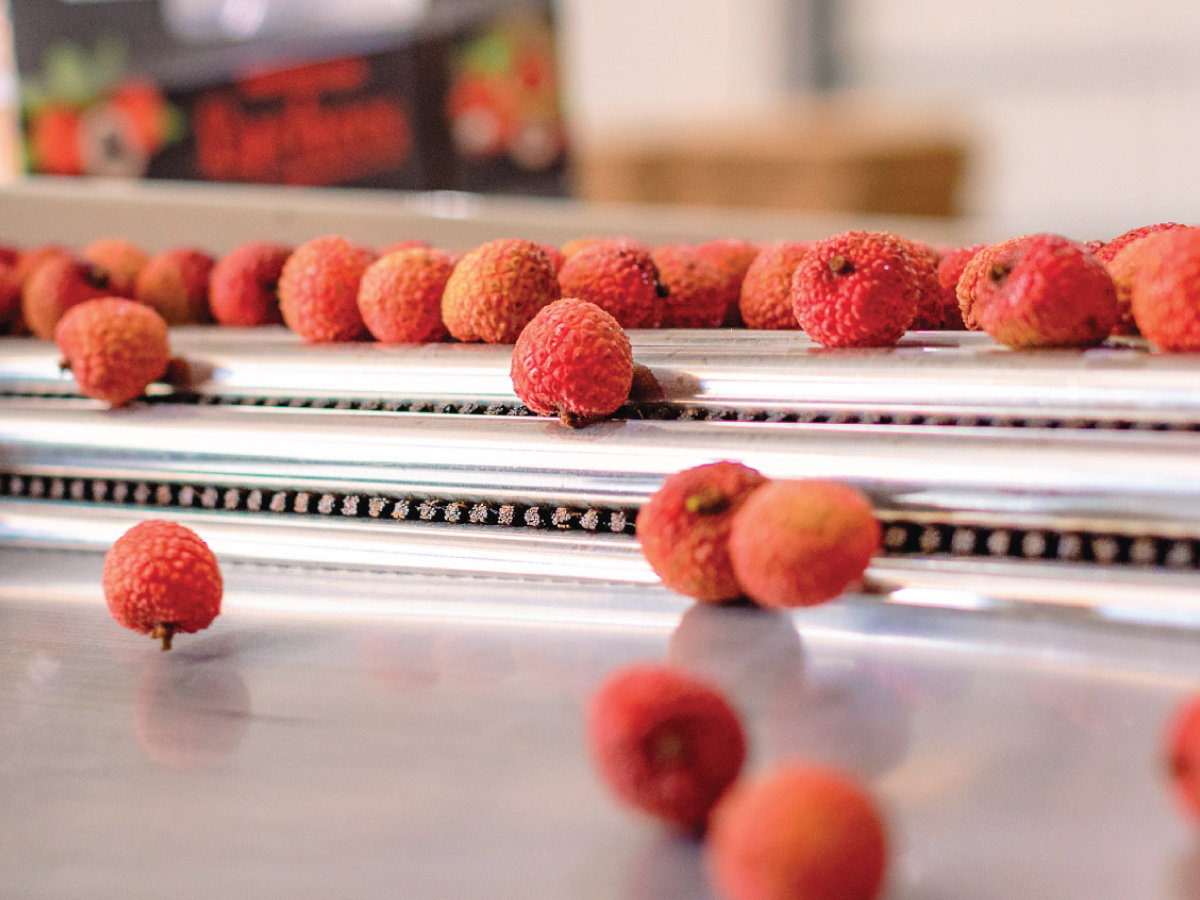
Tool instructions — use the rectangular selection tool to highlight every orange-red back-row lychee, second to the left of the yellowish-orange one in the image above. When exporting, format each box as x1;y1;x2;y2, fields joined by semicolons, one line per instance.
280;234;376;343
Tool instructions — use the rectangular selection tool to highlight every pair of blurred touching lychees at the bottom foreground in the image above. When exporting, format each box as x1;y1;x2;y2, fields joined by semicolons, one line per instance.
587;664;888;900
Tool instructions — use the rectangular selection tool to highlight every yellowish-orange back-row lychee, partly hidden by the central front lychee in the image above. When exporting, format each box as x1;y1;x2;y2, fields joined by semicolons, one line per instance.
442;238;562;343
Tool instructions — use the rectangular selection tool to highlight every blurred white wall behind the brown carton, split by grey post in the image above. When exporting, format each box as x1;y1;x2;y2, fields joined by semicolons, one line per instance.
560;0;1200;239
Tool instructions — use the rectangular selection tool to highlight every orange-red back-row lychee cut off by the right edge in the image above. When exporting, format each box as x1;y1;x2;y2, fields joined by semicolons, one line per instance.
1118;228;1200;353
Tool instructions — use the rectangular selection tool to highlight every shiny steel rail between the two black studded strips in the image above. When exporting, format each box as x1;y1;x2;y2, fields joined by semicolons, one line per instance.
7;400;1200;536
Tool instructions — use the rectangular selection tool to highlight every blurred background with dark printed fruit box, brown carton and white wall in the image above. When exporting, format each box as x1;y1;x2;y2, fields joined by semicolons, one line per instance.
0;0;1200;239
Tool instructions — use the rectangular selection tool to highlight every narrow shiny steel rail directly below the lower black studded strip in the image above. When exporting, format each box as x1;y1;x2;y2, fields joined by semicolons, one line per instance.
7;500;1200;628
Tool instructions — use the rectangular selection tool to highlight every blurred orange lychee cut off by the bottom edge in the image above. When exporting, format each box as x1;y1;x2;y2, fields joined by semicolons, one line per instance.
708;762;888;900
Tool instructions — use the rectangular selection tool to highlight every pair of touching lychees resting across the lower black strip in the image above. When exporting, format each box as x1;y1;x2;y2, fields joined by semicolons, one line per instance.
637;461;881;607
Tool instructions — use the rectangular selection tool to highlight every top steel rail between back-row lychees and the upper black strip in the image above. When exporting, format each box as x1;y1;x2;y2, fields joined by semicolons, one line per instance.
0;328;1200;427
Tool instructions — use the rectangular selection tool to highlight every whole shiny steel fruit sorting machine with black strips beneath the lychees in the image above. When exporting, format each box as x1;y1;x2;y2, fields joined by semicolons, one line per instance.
7;180;1200;900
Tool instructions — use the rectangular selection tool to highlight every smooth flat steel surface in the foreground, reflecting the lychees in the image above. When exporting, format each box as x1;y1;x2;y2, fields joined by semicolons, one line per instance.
0;550;1200;900
